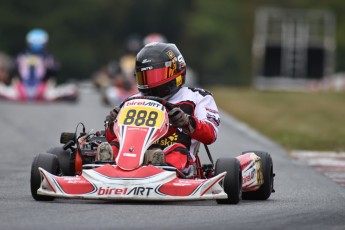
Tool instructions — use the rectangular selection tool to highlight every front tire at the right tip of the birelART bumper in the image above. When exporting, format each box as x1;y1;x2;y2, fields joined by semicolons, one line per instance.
215;158;242;204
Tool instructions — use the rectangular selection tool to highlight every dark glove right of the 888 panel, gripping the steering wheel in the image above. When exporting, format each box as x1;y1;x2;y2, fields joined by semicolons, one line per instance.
168;107;195;134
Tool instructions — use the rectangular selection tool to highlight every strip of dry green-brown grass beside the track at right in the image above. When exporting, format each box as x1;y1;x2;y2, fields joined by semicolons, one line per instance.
210;87;345;151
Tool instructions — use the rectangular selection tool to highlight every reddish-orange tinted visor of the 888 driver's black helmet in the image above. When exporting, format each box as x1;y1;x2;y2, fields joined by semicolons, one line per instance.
136;67;175;88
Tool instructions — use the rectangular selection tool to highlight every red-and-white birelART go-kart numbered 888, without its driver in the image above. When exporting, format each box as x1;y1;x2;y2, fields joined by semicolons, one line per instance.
30;97;274;204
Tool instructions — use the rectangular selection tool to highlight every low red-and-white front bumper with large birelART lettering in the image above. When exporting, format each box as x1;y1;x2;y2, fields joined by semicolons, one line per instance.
37;165;227;201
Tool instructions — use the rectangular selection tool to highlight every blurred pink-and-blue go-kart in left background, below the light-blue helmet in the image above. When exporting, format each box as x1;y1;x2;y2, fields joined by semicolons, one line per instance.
0;54;78;102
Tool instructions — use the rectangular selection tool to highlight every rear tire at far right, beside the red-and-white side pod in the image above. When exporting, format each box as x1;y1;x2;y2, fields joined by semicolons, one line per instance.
242;151;274;200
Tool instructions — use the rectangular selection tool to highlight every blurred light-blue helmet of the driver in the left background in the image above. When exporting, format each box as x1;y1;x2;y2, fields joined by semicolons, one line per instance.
26;29;49;53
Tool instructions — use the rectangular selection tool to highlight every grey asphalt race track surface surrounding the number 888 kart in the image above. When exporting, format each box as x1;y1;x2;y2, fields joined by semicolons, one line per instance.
0;85;345;229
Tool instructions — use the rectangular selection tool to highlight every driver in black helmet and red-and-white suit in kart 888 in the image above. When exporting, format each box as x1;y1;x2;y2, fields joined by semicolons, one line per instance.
98;42;220;172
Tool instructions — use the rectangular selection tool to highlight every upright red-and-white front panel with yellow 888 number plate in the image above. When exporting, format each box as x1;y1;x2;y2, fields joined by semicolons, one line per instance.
114;99;169;170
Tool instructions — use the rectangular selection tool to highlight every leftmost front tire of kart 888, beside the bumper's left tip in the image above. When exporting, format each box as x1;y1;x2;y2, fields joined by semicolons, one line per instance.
30;153;60;201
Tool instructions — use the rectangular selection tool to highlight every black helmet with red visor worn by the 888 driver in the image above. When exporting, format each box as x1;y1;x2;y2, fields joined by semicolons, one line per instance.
135;42;186;98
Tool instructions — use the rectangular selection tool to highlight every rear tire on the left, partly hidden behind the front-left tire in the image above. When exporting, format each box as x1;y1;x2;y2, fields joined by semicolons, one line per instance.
47;147;75;176
